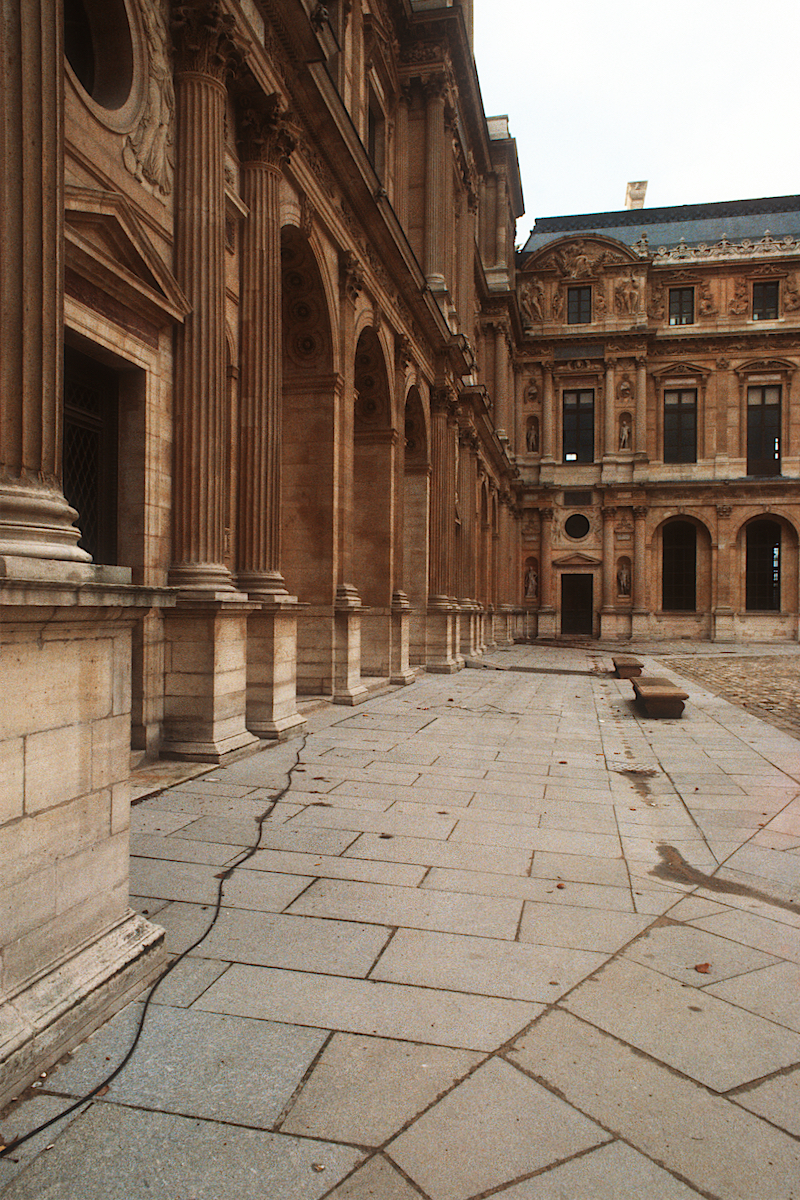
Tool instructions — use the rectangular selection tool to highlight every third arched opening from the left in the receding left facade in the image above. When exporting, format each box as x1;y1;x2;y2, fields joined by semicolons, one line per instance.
403;388;431;666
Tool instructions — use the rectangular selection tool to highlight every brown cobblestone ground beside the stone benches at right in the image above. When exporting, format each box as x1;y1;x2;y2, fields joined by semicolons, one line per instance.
661;654;800;738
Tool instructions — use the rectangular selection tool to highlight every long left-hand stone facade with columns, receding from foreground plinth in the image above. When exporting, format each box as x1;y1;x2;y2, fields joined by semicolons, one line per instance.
0;0;525;1104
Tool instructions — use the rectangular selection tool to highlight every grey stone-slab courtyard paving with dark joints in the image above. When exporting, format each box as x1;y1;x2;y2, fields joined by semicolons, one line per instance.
0;643;800;1200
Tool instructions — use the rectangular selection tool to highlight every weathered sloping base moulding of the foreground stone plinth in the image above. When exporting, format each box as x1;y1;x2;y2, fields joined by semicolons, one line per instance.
0;910;167;1109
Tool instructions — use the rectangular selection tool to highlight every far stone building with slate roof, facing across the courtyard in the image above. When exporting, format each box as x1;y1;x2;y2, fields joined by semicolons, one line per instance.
515;196;800;642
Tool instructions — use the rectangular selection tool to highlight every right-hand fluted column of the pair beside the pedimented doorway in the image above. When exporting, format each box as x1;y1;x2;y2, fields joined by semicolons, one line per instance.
237;92;295;594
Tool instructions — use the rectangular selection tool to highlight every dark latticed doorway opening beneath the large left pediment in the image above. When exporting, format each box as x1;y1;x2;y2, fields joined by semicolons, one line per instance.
64;347;119;564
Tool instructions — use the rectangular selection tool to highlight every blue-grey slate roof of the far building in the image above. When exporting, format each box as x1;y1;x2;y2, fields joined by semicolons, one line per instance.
522;196;800;254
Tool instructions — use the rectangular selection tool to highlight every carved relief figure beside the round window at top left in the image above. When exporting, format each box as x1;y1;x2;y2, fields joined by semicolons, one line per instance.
122;0;175;196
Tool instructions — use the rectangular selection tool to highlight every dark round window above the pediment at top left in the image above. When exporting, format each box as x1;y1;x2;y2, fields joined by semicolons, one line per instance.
64;0;133;112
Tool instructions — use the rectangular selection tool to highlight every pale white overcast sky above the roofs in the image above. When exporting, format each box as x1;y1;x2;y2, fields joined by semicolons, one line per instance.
474;0;800;242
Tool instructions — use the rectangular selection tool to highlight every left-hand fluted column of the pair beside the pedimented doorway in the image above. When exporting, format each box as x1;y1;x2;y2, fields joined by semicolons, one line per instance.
170;0;236;590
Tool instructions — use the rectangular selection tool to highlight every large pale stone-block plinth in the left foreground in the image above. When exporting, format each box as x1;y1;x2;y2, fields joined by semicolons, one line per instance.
0;576;172;1106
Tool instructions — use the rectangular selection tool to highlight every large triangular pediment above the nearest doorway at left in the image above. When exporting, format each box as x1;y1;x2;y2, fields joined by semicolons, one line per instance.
65;186;191;325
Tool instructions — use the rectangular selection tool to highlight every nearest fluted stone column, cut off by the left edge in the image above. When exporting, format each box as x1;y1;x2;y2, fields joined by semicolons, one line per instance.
0;0;90;570
